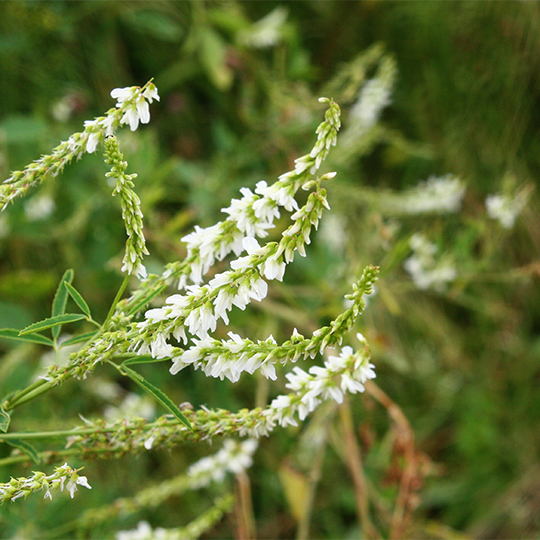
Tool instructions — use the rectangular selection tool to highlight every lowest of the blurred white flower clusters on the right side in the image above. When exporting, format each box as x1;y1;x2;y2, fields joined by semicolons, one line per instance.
403;233;457;291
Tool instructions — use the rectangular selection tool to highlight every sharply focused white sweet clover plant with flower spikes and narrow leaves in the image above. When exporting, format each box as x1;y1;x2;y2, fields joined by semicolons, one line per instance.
0;82;378;534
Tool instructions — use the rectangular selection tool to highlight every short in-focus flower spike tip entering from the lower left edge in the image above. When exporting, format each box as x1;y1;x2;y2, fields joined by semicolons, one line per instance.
0;463;92;504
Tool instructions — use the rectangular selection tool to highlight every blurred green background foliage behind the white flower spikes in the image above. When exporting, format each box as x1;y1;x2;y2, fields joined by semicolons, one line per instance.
0;0;540;538
